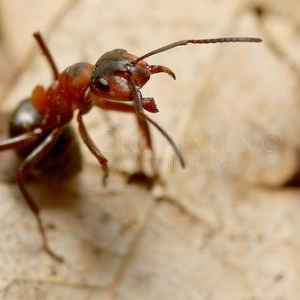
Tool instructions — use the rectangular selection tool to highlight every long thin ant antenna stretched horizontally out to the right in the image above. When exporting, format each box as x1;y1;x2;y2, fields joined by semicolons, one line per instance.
133;37;262;64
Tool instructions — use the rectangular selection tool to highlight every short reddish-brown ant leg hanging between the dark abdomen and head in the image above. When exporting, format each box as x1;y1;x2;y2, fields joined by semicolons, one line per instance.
77;112;109;185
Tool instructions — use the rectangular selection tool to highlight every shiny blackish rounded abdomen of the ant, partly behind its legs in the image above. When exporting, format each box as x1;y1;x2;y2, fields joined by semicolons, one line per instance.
9;99;82;180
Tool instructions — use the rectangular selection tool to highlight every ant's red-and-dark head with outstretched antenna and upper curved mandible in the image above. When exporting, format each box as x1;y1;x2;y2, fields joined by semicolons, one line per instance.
89;37;261;101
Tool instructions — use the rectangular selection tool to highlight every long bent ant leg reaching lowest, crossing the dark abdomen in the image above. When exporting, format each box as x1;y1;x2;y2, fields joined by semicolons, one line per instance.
17;128;63;262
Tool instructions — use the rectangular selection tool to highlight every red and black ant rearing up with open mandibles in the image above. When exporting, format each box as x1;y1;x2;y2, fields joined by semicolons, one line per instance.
0;32;261;261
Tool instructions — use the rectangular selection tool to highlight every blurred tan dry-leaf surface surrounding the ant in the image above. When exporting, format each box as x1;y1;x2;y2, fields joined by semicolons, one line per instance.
0;0;300;300
